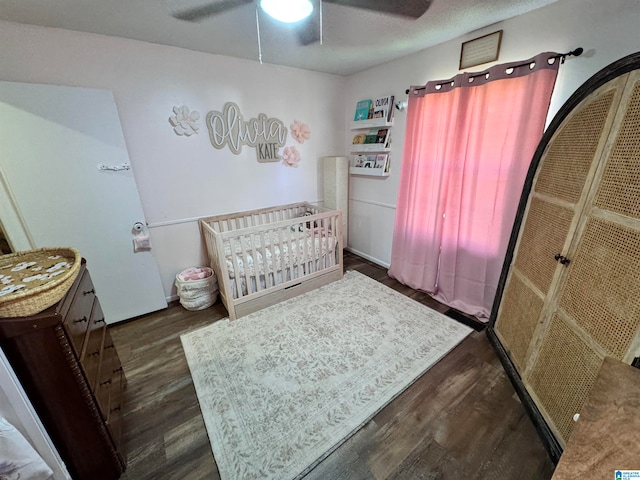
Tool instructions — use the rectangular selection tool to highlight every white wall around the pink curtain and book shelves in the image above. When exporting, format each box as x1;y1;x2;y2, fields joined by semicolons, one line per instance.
344;0;640;266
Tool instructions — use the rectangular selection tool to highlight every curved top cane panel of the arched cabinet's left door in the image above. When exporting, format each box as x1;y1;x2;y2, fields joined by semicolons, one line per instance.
535;90;615;203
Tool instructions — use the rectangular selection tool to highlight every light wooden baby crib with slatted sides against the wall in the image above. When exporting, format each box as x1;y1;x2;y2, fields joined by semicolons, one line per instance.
200;202;343;320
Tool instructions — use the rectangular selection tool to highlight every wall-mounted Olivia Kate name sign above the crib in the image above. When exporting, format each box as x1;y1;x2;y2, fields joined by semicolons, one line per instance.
207;102;287;162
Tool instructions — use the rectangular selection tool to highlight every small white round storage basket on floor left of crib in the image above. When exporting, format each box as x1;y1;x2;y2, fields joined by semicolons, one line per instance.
176;267;219;310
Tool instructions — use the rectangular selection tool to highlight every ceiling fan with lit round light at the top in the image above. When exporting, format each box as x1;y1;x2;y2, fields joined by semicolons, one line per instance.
172;0;433;45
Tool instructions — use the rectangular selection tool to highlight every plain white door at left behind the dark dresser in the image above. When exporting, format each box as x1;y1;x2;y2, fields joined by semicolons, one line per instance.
0;82;167;323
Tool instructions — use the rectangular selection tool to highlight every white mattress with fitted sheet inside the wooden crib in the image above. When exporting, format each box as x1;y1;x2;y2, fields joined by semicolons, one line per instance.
224;229;337;279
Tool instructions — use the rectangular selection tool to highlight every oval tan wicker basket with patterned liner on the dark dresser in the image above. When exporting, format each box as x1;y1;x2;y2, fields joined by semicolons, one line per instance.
0;247;82;318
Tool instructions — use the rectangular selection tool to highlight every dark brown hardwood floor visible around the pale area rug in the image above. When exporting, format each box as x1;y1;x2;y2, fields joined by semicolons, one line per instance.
110;253;554;480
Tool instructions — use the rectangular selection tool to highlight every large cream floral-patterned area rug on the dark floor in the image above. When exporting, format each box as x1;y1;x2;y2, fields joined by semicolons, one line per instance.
181;271;472;480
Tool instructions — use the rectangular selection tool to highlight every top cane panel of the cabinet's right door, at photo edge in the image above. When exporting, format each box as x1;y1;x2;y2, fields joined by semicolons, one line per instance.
595;83;640;218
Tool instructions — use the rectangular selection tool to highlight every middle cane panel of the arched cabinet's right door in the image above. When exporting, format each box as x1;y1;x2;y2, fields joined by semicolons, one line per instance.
559;218;640;359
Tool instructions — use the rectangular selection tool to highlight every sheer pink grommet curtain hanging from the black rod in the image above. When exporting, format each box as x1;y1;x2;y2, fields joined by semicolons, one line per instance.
389;53;560;319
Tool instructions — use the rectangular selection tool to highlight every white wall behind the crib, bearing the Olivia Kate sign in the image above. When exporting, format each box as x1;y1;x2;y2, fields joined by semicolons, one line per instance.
0;21;345;296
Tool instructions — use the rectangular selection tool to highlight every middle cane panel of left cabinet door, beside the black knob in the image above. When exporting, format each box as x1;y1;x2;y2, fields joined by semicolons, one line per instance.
514;197;573;293
